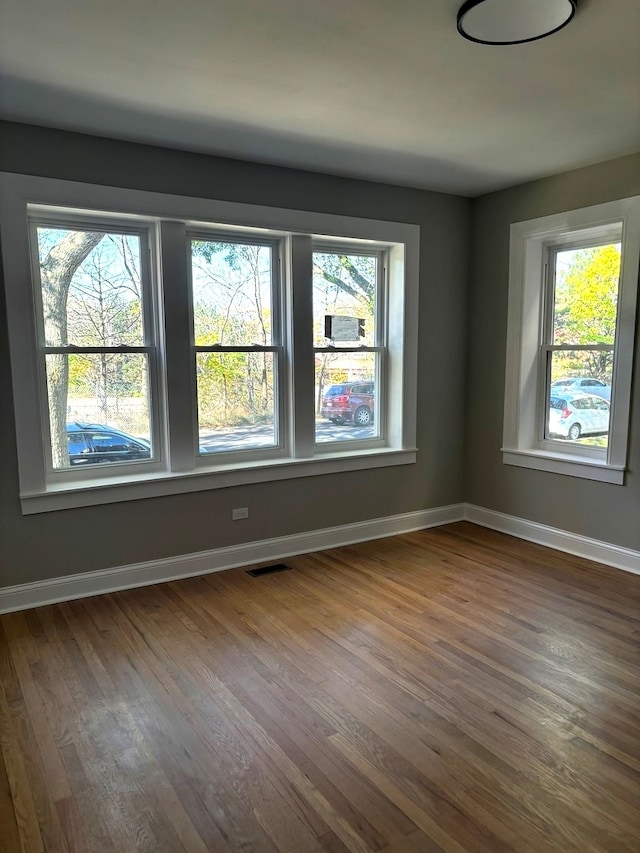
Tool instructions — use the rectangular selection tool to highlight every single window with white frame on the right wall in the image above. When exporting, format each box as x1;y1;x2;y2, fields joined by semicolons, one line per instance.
503;198;640;483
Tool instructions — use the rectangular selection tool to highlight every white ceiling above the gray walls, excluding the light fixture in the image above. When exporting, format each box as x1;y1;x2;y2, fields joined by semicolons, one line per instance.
0;0;640;195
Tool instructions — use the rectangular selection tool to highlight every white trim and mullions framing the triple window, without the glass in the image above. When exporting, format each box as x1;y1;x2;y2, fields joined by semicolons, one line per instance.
0;173;420;514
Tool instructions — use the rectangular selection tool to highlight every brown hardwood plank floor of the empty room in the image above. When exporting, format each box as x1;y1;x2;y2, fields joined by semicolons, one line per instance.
0;523;640;853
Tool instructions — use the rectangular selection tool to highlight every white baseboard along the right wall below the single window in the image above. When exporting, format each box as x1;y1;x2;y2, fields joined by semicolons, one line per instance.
464;504;640;575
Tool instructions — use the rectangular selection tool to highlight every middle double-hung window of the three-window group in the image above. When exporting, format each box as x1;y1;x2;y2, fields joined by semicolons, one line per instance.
189;232;286;460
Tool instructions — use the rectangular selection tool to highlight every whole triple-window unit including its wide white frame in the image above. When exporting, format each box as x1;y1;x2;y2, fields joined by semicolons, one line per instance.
0;170;419;513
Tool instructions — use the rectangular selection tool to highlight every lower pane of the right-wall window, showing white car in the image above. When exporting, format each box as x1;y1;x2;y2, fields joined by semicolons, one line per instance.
546;350;613;447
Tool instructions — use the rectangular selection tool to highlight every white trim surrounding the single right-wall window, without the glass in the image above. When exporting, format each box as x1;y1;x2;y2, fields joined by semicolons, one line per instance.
502;196;640;485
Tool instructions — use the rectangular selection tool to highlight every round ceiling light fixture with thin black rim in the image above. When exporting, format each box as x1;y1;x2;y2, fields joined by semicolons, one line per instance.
458;0;577;44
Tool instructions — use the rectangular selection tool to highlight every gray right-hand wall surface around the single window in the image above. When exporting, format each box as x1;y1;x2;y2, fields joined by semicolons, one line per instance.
465;155;640;549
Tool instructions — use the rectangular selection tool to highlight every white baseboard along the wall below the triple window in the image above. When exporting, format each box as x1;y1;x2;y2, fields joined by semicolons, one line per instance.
0;504;465;613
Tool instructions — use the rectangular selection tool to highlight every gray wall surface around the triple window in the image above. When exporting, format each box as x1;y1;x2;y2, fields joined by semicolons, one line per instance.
0;122;471;586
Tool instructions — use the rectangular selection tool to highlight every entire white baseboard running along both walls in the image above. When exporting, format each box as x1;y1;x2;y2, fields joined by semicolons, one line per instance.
0;503;640;613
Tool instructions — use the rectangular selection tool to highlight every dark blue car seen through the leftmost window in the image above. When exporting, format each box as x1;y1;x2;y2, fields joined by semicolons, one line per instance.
67;422;151;465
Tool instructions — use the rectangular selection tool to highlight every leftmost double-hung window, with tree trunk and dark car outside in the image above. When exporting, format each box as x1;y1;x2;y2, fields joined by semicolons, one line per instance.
29;212;162;476
